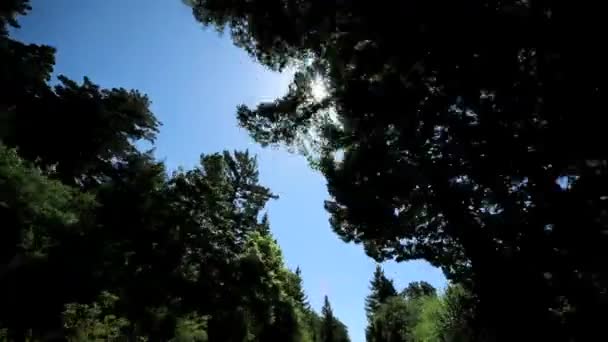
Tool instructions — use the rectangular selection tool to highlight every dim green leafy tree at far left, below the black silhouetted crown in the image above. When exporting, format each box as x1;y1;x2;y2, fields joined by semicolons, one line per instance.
0;144;96;341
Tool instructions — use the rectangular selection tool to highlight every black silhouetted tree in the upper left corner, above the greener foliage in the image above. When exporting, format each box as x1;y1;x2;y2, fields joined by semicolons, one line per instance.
0;0;160;186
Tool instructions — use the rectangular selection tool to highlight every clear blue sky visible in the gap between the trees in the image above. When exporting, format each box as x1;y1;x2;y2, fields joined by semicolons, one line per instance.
14;0;445;342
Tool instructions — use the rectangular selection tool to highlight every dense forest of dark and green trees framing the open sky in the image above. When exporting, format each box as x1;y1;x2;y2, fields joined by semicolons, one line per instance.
0;0;608;342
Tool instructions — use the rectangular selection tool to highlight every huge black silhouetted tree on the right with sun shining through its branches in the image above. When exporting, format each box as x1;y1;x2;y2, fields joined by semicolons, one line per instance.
190;0;608;341
